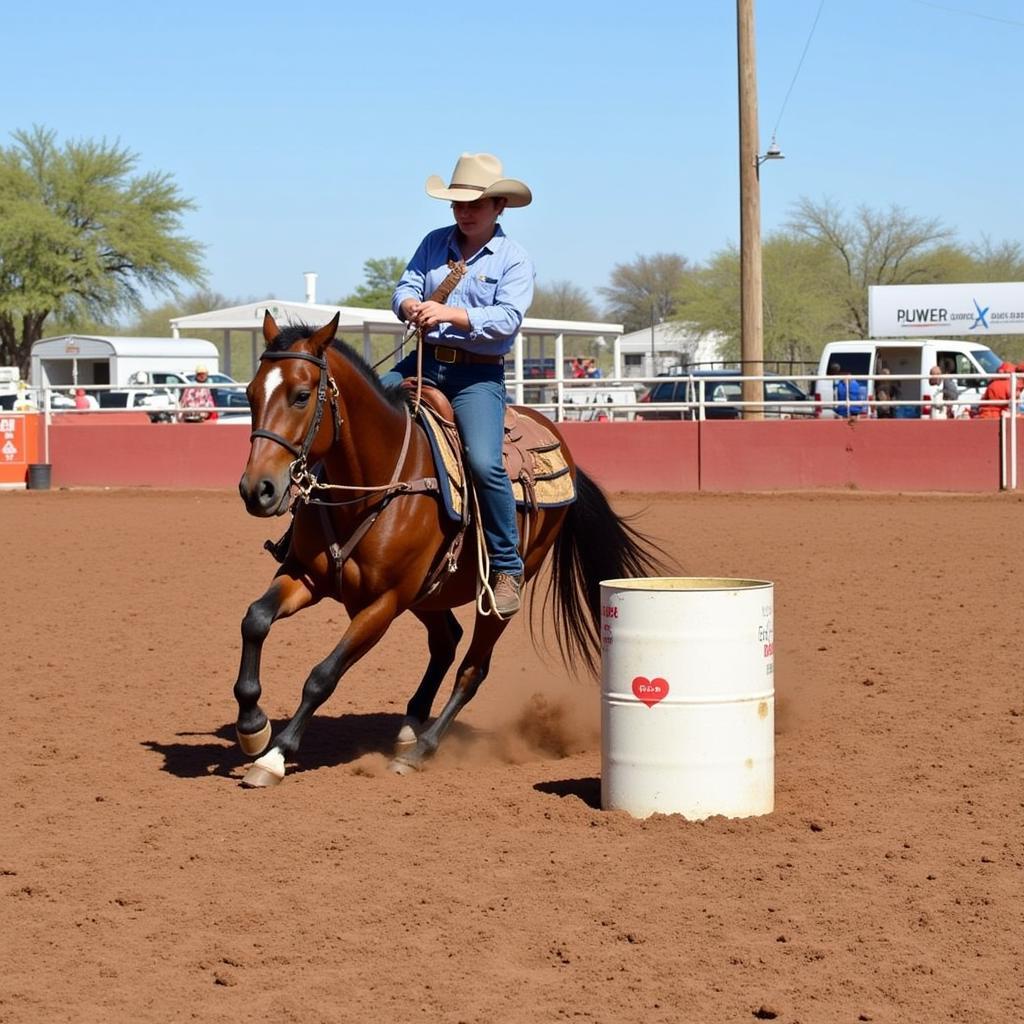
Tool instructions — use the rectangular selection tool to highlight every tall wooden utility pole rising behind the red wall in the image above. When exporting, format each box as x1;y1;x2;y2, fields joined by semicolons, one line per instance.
736;0;765;420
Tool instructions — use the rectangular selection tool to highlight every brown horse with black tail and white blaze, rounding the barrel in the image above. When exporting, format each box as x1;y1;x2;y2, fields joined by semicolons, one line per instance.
234;311;662;786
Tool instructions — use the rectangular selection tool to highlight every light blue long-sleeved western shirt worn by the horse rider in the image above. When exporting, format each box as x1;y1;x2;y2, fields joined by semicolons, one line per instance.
391;224;535;355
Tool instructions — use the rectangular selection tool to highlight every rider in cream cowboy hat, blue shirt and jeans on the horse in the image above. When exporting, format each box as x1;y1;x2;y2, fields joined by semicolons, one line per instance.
383;153;535;617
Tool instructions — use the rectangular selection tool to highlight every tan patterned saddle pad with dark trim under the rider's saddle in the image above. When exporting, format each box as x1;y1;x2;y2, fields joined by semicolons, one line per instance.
420;404;575;522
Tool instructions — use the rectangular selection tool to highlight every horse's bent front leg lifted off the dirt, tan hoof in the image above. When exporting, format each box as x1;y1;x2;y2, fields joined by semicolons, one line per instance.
234;569;315;758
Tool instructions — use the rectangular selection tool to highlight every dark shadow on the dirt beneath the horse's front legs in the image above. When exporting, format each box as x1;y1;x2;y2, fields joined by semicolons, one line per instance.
140;712;411;778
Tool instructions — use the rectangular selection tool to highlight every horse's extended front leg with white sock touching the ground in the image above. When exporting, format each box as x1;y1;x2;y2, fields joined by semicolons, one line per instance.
242;591;398;786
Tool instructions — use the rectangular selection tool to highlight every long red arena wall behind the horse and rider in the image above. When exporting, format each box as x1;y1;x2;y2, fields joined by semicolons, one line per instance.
41;417;1024;493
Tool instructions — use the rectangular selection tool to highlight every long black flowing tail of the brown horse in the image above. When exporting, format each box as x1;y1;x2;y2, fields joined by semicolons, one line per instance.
545;468;669;674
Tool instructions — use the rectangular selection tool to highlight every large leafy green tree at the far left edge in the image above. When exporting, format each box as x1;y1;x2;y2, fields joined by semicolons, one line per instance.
0;127;203;374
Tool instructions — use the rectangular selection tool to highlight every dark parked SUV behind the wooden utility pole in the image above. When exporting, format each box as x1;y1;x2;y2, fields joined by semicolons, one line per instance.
637;370;814;420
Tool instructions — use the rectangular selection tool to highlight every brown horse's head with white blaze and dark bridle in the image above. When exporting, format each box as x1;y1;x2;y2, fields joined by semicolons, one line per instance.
239;311;339;516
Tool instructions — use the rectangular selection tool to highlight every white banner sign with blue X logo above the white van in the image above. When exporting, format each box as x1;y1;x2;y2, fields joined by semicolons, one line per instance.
867;282;1024;338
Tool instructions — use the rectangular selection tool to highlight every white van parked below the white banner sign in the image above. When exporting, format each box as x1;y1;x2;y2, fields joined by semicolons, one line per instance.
814;338;1002;419
